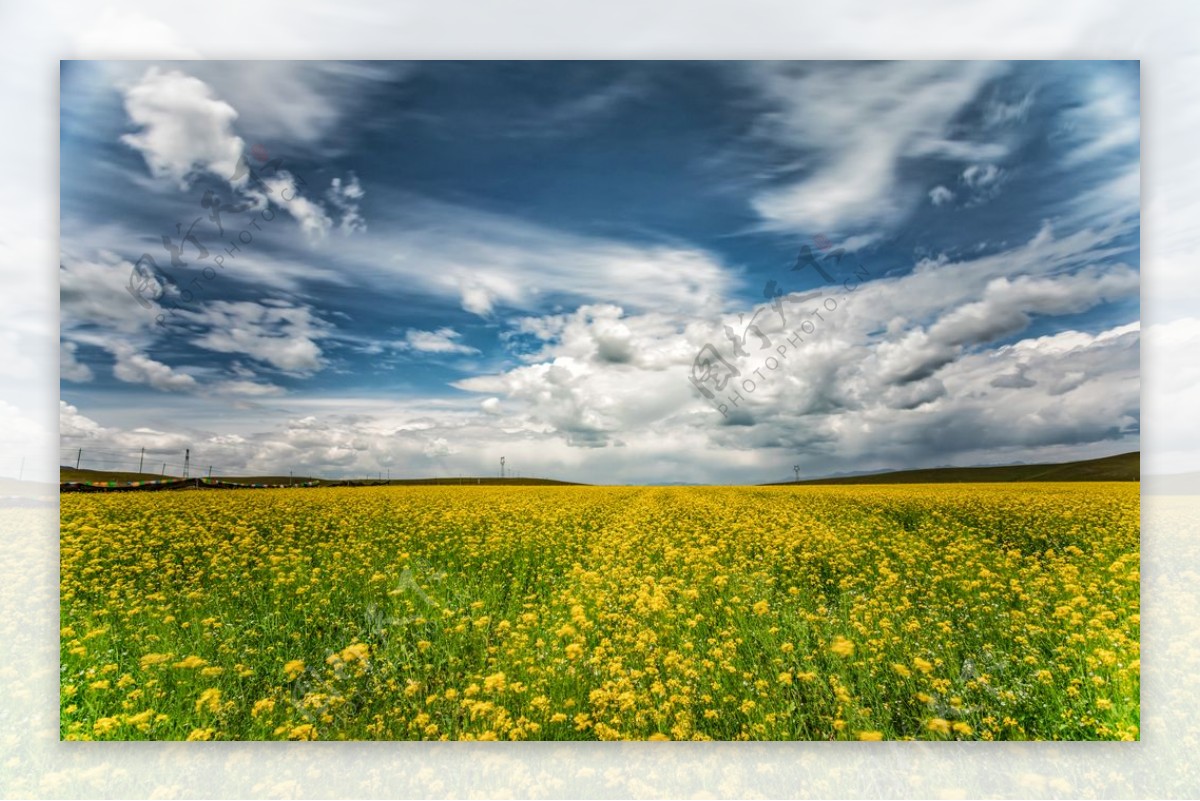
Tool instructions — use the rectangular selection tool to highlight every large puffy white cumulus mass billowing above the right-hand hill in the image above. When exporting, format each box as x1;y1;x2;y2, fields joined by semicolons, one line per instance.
455;221;1138;471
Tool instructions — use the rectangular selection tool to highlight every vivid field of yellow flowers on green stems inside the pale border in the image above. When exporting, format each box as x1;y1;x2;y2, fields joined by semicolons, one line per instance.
60;482;1139;740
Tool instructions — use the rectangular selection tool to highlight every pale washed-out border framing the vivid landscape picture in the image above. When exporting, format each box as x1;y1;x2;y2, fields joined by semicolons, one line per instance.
0;0;1200;797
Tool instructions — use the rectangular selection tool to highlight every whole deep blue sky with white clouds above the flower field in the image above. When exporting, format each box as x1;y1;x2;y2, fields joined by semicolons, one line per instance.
60;61;1140;483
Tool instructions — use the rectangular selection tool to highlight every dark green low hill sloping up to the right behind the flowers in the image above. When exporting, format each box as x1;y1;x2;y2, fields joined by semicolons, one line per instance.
773;451;1141;486
